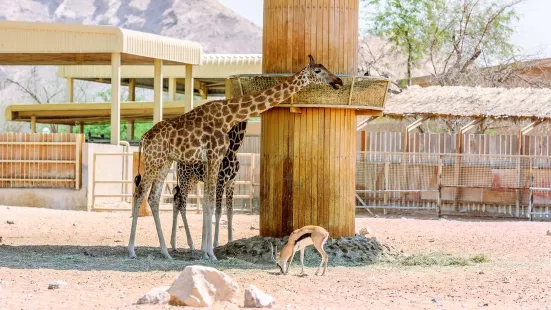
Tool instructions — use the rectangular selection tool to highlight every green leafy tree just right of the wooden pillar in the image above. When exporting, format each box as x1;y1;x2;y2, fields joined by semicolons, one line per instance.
364;0;444;85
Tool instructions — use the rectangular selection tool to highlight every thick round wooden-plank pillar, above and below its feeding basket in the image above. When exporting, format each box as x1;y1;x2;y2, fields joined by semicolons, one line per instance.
260;0;359;238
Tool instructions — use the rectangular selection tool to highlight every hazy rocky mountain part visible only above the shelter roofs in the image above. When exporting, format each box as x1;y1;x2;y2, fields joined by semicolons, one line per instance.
0;0;262;53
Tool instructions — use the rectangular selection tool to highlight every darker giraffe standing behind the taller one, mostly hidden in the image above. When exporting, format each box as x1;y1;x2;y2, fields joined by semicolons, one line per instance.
170;121;247;251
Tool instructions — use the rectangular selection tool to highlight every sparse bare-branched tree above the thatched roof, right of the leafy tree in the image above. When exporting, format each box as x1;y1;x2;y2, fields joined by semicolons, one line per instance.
428;0;524;85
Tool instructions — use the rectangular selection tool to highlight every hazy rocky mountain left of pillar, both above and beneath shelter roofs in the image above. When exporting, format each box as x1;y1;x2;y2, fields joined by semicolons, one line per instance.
0;0;262;132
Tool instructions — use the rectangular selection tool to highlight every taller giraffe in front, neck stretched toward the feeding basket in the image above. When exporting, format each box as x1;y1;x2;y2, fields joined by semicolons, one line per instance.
128;55;342;260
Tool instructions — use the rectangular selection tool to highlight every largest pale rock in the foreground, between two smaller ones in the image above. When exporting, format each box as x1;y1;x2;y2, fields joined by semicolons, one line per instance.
168;266;239;307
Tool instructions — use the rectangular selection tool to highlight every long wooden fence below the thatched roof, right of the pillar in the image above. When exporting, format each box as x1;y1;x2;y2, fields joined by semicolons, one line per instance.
356;152;551;218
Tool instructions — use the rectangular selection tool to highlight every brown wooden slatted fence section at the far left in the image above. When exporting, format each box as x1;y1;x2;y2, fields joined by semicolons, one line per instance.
0;133;84;189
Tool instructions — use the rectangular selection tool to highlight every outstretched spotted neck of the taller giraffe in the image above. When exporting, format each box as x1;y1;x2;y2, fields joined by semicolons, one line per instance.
227;67;310;126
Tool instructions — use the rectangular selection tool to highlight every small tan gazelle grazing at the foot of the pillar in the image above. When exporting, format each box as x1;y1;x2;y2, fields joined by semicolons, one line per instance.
270;225;329;276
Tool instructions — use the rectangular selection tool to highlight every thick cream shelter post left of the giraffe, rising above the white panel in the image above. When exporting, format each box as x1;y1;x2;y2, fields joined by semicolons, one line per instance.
111;53;121;145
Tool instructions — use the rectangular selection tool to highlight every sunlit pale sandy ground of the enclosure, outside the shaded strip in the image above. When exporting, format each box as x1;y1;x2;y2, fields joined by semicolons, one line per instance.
0;206;551;309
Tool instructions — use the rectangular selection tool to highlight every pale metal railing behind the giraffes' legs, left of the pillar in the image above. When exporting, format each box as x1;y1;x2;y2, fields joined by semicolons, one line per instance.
88;152;259;211
